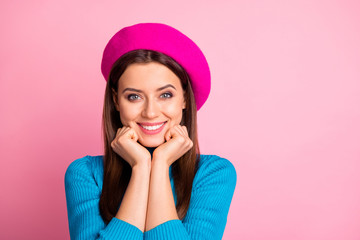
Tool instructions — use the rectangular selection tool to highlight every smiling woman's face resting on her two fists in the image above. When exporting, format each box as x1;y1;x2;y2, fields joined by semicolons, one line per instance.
114;62;185;147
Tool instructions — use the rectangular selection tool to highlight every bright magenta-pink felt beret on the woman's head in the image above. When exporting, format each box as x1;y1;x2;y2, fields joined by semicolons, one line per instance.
101;23;210;110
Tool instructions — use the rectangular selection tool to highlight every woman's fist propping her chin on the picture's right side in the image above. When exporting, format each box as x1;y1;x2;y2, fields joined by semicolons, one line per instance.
152;125;193;167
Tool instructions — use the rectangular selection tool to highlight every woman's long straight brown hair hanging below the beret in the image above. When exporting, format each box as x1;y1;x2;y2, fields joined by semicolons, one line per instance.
99;49;200;223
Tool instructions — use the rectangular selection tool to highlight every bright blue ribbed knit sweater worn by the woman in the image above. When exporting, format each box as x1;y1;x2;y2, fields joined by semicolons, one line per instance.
65;155;237;240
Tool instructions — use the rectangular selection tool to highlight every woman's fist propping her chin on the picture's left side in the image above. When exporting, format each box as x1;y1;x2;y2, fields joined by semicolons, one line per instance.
111;126;151;168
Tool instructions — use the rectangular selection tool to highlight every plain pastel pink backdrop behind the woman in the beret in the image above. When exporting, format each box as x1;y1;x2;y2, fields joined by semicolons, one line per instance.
0;0;360;240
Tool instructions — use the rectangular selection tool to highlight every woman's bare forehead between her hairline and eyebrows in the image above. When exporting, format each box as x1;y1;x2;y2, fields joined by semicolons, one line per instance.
119;62;181;90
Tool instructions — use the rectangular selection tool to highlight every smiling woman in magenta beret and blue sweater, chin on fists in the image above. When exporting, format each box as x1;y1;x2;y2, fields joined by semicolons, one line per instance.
65;23;236;240
